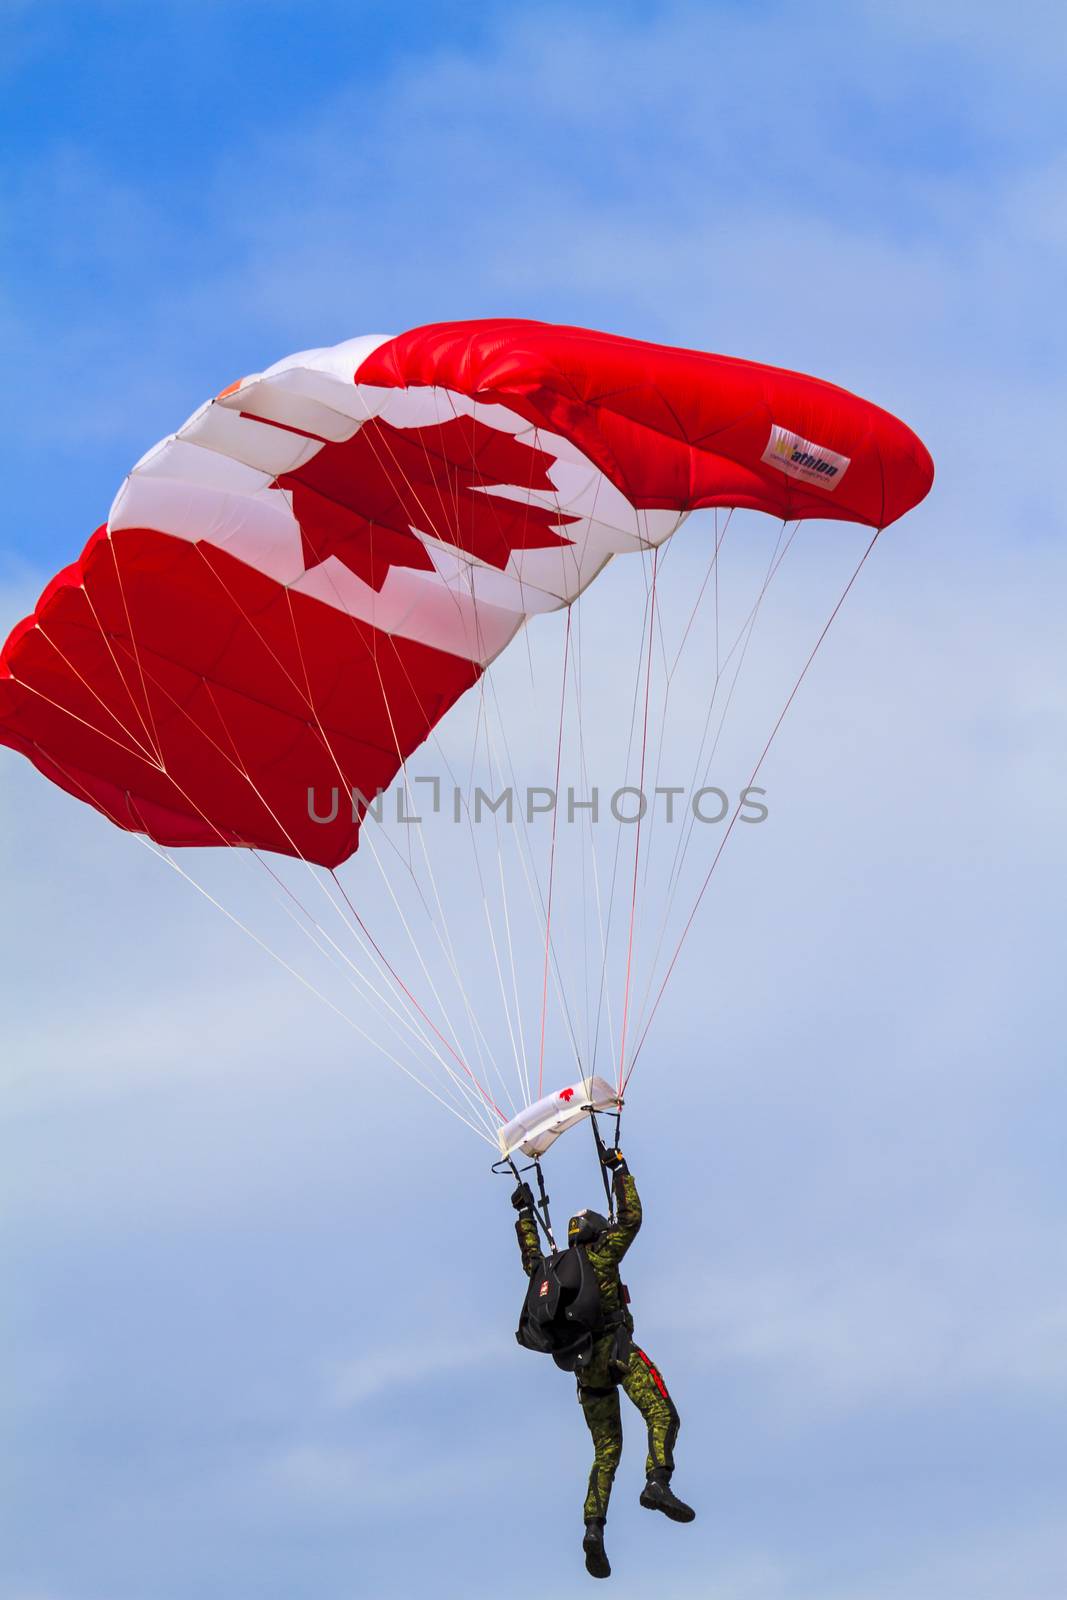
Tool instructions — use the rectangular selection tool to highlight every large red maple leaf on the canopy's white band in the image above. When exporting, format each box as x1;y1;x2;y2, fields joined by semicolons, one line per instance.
271;416;577;589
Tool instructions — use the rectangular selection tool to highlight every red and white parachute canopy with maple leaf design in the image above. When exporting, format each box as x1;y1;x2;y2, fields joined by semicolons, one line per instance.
0;320;933;867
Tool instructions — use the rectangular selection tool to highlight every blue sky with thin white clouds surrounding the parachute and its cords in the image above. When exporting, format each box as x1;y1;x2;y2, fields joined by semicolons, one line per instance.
0;0;1067;1600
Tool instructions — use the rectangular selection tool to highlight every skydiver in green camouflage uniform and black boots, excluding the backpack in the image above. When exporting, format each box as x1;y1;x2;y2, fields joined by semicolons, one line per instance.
512;1149;696;1578
